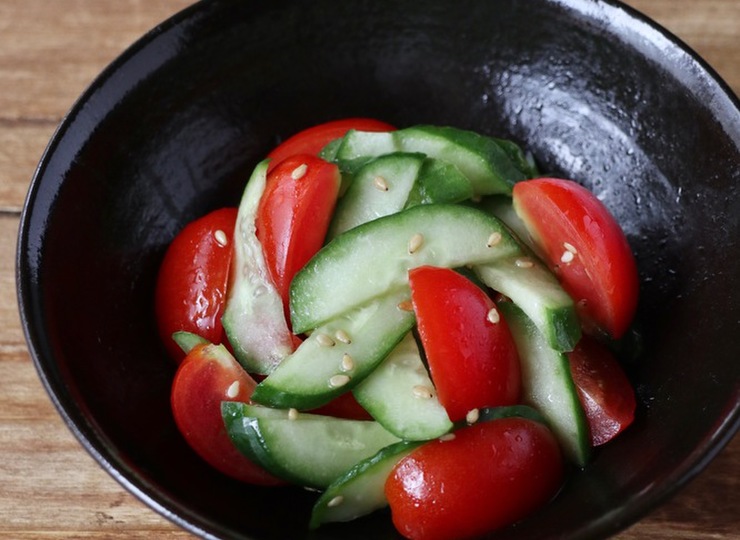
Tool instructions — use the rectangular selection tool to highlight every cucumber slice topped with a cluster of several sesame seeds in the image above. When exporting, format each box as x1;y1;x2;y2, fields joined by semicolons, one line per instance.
252;292;415;409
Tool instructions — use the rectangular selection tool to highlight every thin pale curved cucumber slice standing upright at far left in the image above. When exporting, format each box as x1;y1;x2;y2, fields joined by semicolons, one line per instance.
222;161;293;375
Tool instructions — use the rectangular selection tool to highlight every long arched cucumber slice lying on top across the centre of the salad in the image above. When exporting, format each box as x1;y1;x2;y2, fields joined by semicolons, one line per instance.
290;204;521;333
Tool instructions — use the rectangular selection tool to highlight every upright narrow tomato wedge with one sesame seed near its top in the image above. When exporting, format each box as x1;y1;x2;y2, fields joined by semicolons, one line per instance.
256;154;341;306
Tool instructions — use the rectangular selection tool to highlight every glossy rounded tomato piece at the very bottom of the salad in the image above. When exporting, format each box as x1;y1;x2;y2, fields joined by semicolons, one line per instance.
385;417;564;540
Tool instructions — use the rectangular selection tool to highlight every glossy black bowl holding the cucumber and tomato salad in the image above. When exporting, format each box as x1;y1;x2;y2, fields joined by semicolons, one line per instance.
18;0;740;539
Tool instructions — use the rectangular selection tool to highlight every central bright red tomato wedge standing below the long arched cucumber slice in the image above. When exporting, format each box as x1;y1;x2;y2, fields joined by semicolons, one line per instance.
409;266;521;422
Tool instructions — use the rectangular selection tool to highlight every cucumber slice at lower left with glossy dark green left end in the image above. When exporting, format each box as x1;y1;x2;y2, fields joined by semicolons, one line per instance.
221;402;399;489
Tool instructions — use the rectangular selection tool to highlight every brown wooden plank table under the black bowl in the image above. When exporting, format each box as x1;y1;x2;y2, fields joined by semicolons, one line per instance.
0;0;740;540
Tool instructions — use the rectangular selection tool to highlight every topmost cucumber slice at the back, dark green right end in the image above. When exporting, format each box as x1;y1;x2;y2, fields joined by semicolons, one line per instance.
335;126;531;195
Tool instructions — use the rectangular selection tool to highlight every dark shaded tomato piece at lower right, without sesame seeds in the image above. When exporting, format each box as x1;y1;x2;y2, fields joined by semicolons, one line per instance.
568;336;637;446
